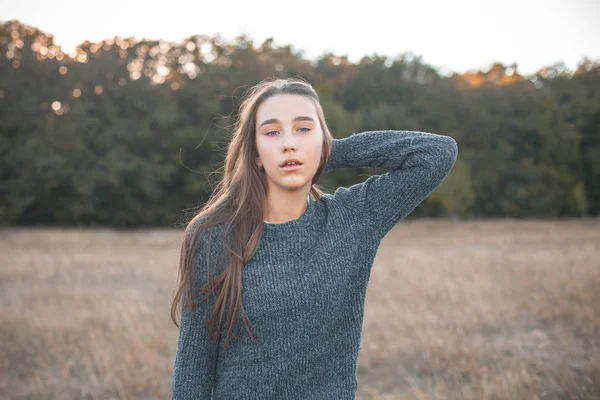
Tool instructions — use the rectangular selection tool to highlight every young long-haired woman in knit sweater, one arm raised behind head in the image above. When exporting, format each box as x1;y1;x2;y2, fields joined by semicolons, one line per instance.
171;79;458;400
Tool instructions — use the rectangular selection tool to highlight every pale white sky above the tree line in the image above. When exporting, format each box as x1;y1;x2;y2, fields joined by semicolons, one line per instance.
0;0;600;75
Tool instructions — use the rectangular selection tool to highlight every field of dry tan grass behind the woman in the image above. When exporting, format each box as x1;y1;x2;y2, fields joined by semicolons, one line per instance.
0;220;600;400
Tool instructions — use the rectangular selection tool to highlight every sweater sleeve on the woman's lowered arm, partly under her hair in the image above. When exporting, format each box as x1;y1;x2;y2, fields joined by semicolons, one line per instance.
171;238;219;400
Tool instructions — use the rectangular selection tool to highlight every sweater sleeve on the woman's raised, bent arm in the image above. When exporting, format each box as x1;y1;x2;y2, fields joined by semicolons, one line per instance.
325;130;458;238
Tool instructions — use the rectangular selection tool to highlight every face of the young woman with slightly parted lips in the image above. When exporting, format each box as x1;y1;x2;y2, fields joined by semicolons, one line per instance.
255;94;323;190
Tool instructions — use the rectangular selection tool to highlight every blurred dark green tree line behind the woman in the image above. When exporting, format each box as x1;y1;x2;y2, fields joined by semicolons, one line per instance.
0;20;600;227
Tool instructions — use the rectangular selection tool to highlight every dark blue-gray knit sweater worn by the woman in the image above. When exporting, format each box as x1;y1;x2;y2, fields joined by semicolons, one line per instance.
172;130;458;400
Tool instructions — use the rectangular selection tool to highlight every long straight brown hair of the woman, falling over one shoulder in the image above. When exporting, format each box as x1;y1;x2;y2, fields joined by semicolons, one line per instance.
171;78;333;346
